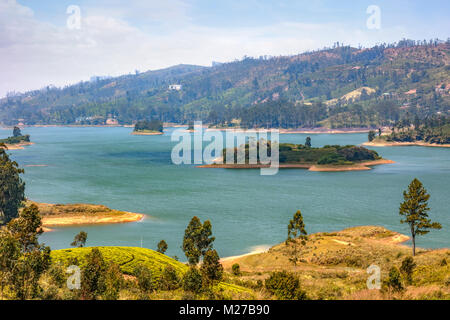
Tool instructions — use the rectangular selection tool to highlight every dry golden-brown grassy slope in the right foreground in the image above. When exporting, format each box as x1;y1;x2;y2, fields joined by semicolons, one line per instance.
224;227;450;299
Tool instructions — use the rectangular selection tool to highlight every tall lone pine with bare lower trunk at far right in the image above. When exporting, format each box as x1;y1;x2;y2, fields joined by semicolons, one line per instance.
399;179;442;256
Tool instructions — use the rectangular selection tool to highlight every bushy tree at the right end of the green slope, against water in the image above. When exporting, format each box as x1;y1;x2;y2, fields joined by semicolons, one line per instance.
182;217;215;266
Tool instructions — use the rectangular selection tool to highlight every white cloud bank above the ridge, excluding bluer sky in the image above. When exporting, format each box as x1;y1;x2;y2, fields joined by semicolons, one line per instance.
0;0;416;96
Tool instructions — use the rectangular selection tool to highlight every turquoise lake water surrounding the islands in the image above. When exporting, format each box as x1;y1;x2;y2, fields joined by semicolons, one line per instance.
0;127;450;260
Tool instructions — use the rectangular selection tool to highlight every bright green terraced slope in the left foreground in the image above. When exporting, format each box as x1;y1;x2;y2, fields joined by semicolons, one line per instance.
52;247;252;298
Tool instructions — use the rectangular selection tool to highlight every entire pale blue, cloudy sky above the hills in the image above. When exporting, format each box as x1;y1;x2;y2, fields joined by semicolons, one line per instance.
0;0;450;96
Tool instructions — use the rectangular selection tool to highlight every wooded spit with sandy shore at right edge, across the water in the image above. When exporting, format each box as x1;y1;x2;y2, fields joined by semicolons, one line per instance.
364;117;450;148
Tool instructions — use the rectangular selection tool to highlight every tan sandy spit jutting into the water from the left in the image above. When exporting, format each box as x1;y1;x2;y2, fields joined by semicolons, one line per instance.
29;201;146;232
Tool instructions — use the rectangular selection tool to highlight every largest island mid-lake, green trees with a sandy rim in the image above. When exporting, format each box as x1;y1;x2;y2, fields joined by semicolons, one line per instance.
199;137;394;172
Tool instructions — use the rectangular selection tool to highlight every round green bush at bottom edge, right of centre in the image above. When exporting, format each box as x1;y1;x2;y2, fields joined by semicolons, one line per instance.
265;271;306;300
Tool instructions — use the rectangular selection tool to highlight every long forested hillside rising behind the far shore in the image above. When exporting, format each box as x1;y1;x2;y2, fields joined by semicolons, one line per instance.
0;40;450;128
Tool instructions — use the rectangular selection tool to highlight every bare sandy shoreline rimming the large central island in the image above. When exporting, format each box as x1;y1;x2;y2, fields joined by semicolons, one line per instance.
197;159;395;172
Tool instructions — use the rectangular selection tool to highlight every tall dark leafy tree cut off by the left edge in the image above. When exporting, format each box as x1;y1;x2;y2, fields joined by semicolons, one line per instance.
0;144;25;225
